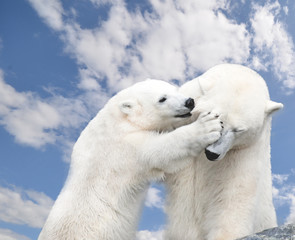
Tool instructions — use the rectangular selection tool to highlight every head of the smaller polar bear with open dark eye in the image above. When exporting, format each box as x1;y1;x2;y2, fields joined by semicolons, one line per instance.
114;79;195;131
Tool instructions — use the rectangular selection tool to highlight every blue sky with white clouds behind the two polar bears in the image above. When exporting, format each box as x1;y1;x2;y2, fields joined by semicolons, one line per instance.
0;0;295;240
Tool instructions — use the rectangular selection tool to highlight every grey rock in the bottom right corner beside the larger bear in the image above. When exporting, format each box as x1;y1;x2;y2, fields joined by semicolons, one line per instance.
239;224;295;240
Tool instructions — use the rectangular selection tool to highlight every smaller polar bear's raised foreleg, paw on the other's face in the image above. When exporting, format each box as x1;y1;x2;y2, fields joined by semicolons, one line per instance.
140;113;222;173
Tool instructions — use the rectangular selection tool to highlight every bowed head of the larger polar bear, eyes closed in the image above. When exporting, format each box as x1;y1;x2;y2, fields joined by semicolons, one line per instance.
180;64;283;161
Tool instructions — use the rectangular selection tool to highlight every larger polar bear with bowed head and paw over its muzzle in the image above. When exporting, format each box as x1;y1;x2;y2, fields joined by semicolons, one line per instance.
165;64;283;240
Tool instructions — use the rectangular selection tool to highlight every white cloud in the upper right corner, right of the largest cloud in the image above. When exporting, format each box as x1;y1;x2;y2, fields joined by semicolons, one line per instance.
251;1;295;89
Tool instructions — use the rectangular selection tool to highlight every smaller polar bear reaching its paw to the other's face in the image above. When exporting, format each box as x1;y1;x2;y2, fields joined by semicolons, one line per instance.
39;80;221;240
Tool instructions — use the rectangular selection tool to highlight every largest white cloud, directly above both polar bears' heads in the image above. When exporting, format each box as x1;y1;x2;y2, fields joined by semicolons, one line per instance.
27;0;250;92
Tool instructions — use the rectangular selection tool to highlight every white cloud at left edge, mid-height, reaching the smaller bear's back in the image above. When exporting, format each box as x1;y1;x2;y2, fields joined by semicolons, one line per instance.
0;70;107;152
